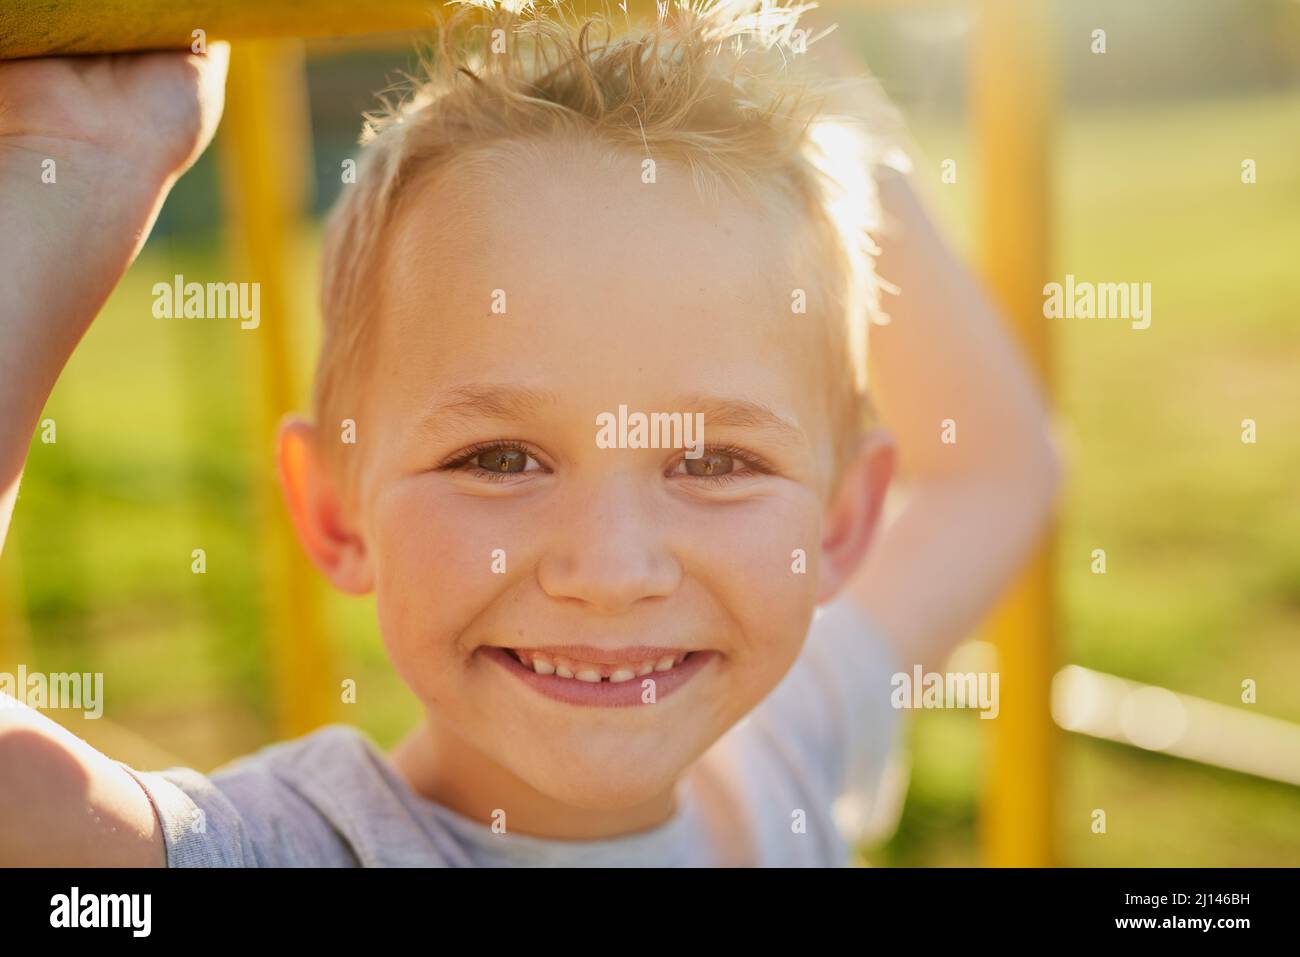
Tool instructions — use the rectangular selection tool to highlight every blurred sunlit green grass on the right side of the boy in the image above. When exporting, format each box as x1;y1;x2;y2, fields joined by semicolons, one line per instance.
872;95;1300;866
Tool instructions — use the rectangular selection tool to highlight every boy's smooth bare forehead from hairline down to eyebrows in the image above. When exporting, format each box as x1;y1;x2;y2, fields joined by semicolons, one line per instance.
380;135;827;452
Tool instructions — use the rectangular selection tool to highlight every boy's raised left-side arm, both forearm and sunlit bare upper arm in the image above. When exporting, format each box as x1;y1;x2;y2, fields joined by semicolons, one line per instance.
0;47;226;866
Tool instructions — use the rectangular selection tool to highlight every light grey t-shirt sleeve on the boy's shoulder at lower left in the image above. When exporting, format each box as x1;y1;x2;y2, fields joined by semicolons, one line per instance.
118;762;356;867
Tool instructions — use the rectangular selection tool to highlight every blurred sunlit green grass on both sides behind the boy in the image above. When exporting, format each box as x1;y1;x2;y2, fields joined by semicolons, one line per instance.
3;89;1300;865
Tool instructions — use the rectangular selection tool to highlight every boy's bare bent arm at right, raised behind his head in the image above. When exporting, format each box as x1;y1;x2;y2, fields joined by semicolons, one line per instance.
848;172;1061;668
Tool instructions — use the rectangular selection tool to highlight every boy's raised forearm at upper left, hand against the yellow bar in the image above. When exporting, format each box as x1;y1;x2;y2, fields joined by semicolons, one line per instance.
0;44;228;547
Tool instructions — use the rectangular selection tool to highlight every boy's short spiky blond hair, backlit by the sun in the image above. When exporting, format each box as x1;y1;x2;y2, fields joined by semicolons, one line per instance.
313;0;898;478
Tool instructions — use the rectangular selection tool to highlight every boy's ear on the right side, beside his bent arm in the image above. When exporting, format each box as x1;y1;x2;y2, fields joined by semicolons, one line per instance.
816;429;897;605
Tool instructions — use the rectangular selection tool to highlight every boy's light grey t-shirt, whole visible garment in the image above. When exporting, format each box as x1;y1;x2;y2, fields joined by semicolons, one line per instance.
122;601;902;867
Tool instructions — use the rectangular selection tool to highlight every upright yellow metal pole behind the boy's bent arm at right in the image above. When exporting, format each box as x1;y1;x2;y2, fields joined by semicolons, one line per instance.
970;0;1056;867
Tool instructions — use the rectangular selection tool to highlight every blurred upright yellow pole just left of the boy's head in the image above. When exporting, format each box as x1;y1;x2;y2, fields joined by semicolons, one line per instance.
221;40;338;739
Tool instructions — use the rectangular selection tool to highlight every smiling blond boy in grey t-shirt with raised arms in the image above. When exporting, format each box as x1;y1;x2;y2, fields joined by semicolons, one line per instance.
0;0;1052;866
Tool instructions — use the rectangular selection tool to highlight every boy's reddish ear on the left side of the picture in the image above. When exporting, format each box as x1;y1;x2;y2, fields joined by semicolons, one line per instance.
277;416;374;594
